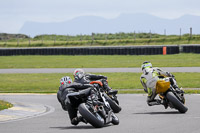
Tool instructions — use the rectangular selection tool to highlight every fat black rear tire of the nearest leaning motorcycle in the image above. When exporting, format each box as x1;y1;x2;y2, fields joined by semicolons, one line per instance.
78;103;104;128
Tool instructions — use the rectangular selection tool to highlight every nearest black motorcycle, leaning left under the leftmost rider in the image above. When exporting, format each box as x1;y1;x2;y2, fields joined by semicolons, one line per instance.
67;88;119;128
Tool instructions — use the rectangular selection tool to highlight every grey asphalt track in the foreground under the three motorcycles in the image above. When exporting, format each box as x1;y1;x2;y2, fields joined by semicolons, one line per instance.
0;94;200;133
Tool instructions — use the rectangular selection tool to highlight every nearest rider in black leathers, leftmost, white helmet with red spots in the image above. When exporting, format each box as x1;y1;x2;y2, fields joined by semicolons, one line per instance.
57;76;94;125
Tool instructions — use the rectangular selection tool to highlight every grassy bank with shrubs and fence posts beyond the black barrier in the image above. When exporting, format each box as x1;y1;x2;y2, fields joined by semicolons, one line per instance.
0;33;200;47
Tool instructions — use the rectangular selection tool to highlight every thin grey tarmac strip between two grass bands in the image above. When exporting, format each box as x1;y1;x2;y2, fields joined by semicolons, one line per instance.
0;67;200;73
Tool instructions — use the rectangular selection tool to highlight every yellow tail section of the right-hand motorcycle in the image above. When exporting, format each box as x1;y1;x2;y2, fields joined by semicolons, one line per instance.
156;80;170;94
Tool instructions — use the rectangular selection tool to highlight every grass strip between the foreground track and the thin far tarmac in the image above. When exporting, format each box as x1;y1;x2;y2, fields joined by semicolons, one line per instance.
0;73;200;93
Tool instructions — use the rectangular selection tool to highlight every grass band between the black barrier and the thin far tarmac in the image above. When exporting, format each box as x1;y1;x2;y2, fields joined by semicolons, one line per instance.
0;54;200;68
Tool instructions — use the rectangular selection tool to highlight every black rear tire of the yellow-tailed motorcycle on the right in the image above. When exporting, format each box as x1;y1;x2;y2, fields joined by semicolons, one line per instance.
166;92;188;113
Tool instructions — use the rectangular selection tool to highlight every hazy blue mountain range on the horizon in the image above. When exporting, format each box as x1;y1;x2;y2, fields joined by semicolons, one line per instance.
19;13;200;37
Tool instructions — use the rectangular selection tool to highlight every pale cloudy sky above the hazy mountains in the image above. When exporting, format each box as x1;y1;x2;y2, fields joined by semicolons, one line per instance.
0;0;200;33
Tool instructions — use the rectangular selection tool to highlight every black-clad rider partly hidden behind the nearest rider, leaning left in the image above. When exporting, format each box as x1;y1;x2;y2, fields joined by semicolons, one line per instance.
73;69;117;94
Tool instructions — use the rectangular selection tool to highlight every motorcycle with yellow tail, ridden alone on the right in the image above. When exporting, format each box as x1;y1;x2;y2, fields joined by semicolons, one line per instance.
156;79;188;113
